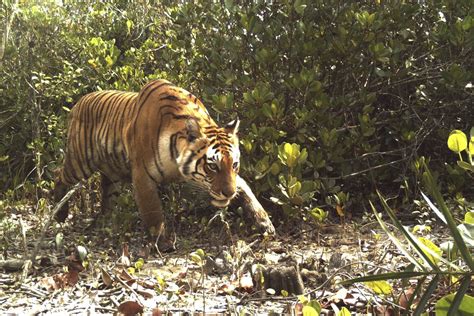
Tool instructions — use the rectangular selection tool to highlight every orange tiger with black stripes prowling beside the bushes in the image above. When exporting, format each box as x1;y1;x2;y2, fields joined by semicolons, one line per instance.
54;79;275;247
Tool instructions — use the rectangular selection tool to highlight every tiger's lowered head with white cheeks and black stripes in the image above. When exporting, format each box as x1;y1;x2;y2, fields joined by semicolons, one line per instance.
177;119;240;207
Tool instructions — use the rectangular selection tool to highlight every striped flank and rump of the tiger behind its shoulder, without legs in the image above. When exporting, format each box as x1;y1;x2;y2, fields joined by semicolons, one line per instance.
61;90;138;185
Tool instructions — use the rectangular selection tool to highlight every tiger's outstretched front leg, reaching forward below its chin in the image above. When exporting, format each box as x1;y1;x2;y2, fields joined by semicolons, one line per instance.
236;175;275;235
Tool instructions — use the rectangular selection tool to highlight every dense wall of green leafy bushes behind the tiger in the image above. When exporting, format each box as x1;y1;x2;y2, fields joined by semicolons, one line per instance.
0;0;474;215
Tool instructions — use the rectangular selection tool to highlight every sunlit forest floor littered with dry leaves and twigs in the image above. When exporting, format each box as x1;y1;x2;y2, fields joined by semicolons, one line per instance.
0;194;448;315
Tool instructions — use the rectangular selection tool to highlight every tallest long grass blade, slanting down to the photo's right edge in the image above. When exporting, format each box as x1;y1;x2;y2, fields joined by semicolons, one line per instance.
423;161;474;271
